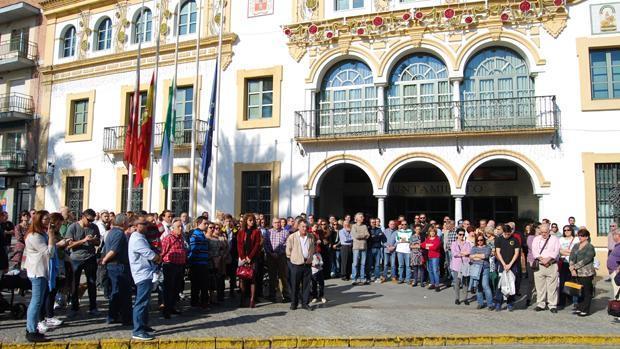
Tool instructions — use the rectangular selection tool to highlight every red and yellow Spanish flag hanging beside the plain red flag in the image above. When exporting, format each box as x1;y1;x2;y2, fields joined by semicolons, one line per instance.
134;72;155;187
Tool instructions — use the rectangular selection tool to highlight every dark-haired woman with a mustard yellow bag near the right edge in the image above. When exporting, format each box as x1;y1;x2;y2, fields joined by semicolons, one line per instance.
568;228;596;316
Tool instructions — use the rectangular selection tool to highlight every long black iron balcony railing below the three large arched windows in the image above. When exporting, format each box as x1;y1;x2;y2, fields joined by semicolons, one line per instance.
295;96;559;139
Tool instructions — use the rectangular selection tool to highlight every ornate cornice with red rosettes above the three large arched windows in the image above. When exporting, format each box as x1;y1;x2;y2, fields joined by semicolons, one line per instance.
283;0;568;61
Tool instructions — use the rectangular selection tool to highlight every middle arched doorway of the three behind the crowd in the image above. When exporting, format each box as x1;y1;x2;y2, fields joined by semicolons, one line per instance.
385;161;454;222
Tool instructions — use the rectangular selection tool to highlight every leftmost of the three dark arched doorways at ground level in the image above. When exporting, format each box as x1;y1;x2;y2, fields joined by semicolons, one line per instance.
314;164;377;217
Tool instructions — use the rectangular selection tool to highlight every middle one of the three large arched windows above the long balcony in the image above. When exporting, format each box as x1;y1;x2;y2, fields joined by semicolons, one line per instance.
387;53;452;132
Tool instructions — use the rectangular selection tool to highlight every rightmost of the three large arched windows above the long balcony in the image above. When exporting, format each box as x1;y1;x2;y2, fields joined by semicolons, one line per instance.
461;47;536;128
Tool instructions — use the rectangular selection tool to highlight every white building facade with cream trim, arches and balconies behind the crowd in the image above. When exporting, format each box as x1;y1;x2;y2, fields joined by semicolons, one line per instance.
39;0;620;258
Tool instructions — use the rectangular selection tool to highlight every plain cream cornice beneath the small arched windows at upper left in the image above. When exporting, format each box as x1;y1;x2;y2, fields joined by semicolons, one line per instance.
40;33;237;85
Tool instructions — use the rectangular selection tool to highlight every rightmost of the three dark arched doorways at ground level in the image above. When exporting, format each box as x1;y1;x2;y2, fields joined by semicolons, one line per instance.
463;159;539;223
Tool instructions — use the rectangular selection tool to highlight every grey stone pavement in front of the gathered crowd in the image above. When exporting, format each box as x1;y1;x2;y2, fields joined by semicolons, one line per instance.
0;279;620;342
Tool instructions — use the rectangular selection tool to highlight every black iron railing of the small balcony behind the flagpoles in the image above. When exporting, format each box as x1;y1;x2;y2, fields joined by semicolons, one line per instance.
103;120;209;152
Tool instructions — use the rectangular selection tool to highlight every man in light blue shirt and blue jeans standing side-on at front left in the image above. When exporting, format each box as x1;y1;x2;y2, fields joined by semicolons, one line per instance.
128;217;161;340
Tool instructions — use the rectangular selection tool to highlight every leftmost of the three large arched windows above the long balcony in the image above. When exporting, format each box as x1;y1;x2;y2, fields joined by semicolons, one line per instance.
318;60;378;134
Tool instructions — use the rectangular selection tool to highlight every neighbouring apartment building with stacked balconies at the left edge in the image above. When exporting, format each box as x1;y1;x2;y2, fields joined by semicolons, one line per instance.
0;0;45;220
